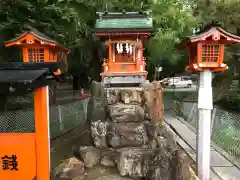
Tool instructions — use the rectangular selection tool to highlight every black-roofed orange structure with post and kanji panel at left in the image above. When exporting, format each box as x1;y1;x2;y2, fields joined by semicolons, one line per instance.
0;63;59;180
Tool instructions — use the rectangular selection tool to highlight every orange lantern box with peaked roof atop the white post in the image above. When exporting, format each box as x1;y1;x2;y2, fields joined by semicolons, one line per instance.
179;27;240;72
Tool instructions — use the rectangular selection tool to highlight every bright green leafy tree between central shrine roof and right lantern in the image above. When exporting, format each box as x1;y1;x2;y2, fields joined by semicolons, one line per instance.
148;0;197;64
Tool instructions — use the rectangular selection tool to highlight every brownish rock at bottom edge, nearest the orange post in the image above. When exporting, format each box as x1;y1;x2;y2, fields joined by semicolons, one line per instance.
55;157;84;180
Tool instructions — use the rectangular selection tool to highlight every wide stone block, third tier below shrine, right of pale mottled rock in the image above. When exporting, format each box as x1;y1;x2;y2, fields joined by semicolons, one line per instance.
107;123;148;148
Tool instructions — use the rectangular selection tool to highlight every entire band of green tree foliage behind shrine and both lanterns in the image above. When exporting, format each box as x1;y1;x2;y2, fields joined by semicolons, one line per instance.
0;0;240;82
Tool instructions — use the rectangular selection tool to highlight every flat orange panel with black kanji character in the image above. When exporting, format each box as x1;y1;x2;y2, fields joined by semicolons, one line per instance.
0;132;36;180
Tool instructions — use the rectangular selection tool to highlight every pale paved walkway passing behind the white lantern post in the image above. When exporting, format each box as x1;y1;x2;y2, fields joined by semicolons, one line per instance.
165;114;240;180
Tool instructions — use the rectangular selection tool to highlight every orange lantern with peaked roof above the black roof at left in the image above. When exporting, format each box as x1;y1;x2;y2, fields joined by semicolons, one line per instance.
5;29;69;73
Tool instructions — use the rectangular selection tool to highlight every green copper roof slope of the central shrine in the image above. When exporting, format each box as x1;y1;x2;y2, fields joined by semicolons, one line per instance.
95;18;153;29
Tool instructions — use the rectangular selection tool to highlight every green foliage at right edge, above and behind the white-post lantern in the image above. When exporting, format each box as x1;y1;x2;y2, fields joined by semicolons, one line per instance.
192;0;240;104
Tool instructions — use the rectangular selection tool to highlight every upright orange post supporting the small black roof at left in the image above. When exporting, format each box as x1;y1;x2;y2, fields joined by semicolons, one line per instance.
34;86;50;180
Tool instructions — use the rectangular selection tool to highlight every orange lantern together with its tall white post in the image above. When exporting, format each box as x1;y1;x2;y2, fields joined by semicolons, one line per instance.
177;25;240;180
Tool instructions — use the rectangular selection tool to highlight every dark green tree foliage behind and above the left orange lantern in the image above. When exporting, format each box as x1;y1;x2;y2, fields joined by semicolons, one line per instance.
0;0;100;73
